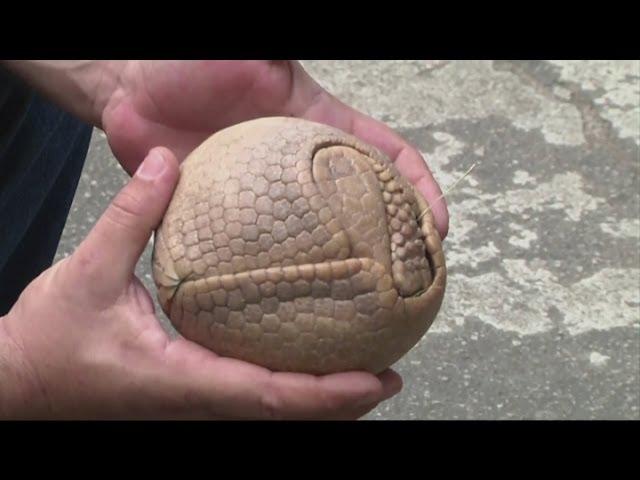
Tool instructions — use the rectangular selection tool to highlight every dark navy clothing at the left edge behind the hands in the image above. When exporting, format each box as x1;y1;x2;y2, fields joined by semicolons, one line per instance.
0;68;92;315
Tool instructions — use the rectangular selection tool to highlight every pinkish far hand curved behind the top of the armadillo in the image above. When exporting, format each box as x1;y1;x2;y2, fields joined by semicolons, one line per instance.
96;61;449;238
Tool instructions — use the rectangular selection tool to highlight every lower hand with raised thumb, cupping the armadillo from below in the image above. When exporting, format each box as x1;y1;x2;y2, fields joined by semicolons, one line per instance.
0;148;402;419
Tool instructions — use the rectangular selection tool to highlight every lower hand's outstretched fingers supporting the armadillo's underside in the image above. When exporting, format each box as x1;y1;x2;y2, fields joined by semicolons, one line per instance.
160;338;390;420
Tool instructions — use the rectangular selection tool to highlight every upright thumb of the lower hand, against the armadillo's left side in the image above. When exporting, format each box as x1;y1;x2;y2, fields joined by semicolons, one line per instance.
72;147;179;293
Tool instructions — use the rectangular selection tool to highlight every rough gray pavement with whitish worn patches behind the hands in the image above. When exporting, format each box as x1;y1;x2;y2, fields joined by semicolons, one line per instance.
58;61;640;419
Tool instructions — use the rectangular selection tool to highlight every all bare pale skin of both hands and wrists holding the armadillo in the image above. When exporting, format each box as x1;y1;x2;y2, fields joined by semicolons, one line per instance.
0;61;448;419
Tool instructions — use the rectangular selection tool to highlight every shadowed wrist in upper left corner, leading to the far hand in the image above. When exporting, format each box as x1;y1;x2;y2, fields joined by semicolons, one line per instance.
0;60;126;128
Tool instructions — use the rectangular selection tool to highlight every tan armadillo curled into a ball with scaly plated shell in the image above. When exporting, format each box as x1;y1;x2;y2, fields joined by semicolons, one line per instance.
153;117;446;374
